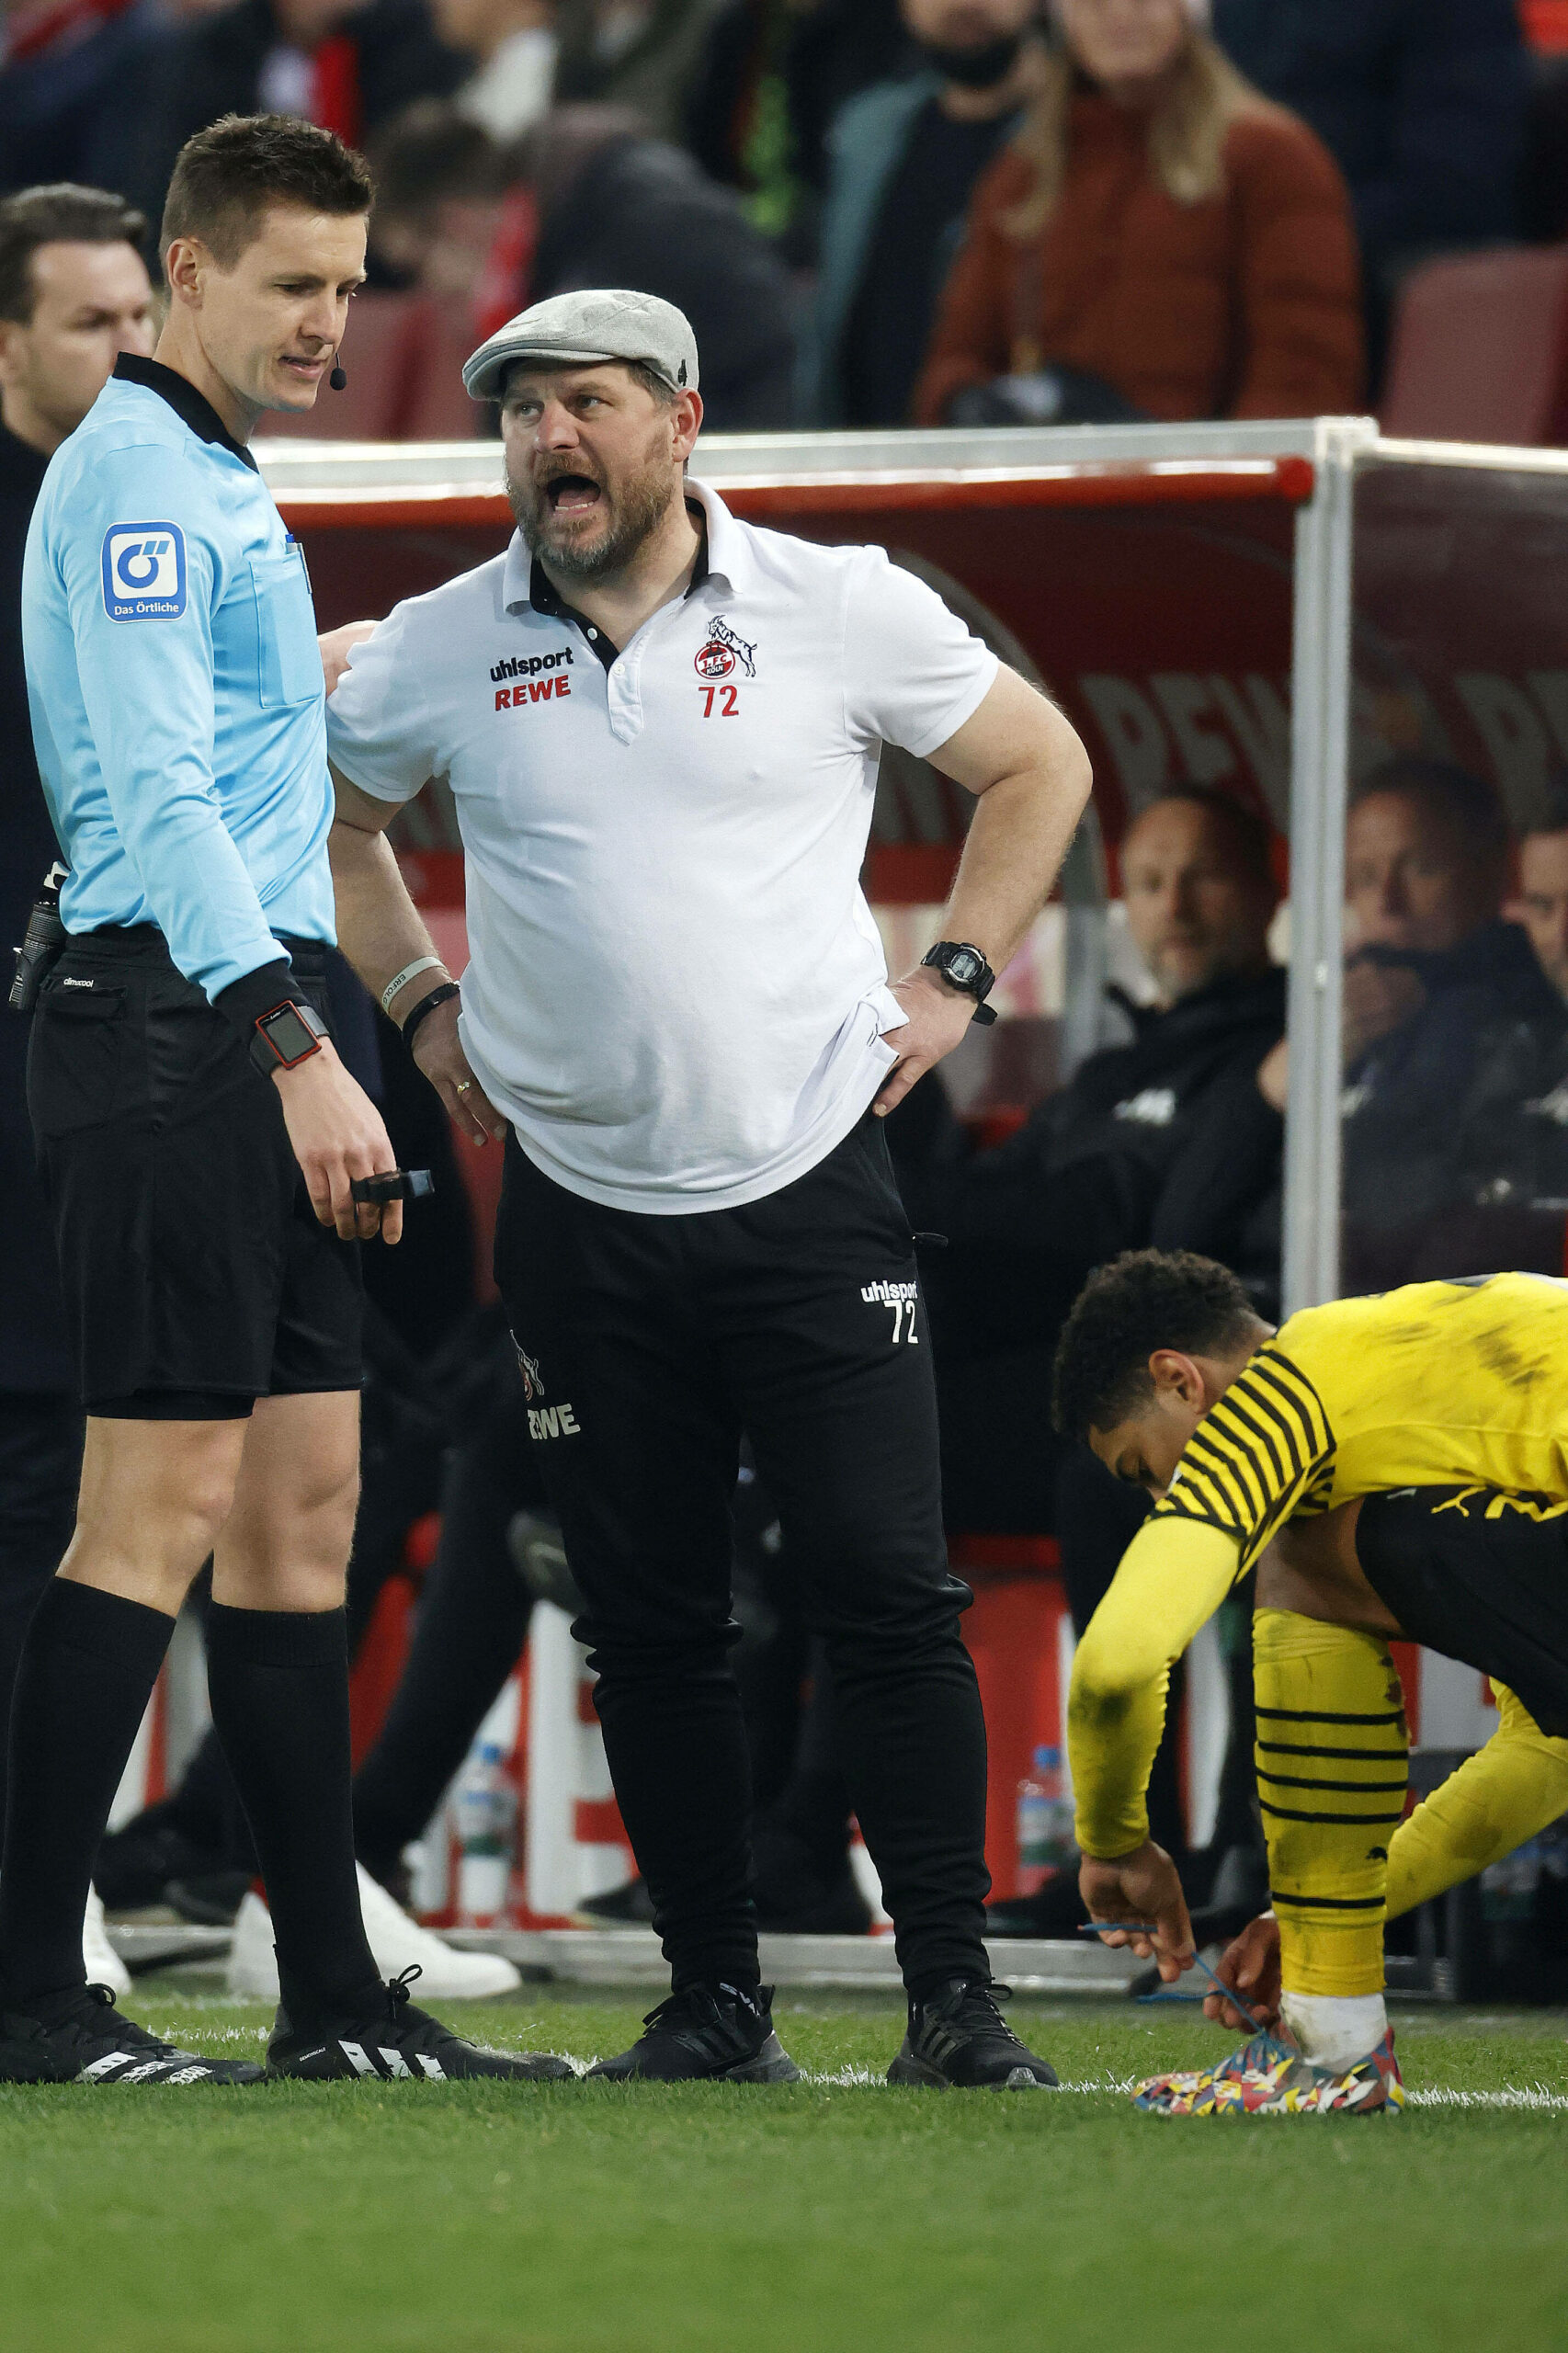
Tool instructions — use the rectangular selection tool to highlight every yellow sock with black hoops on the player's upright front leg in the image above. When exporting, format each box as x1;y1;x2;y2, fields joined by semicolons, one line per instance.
1253;1609;1408;1995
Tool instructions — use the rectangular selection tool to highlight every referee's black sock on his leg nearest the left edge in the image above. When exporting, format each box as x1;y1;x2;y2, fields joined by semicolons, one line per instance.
0;1576;175;2009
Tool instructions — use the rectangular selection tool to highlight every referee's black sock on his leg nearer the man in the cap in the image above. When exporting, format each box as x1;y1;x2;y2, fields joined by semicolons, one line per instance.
207;1602;381;2029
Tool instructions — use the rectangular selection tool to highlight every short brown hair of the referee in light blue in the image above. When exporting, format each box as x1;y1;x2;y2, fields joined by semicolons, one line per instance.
158;115;374;270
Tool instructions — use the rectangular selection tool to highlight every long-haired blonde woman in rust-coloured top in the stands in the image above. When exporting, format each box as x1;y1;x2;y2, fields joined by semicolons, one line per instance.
914;0;1363;426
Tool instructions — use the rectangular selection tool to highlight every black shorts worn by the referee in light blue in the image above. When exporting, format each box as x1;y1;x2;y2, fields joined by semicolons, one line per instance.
28;925;362;1421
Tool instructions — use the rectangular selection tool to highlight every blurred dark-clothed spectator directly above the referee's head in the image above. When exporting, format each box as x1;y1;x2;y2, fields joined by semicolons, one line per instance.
120;0;471;236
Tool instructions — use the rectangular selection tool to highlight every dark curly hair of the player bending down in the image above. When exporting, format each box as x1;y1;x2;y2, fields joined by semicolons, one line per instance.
1052;1249;1259;1438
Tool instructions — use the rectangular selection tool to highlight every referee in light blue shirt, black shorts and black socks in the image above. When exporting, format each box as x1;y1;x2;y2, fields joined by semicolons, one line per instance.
0;115;570;2085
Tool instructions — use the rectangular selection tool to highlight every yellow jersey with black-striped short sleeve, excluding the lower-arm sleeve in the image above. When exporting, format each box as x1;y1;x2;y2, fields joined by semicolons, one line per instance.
1153;1276;1568;1574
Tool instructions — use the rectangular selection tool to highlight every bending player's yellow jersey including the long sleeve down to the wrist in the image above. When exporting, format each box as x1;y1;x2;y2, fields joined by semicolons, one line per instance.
1069;1276;1568;1854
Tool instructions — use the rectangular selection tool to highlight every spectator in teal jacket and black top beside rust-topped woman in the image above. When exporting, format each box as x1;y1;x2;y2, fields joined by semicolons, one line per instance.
801;0;1045;426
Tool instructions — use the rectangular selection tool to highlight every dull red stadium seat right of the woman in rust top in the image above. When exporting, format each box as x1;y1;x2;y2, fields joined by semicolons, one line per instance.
1382;244;1568;447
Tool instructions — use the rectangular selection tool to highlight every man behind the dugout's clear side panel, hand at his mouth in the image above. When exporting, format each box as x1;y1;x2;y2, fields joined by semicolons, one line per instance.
1262;757;1563;1291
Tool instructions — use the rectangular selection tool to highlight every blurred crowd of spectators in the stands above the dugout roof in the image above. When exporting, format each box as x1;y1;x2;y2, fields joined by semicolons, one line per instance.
0;0;1568;438
